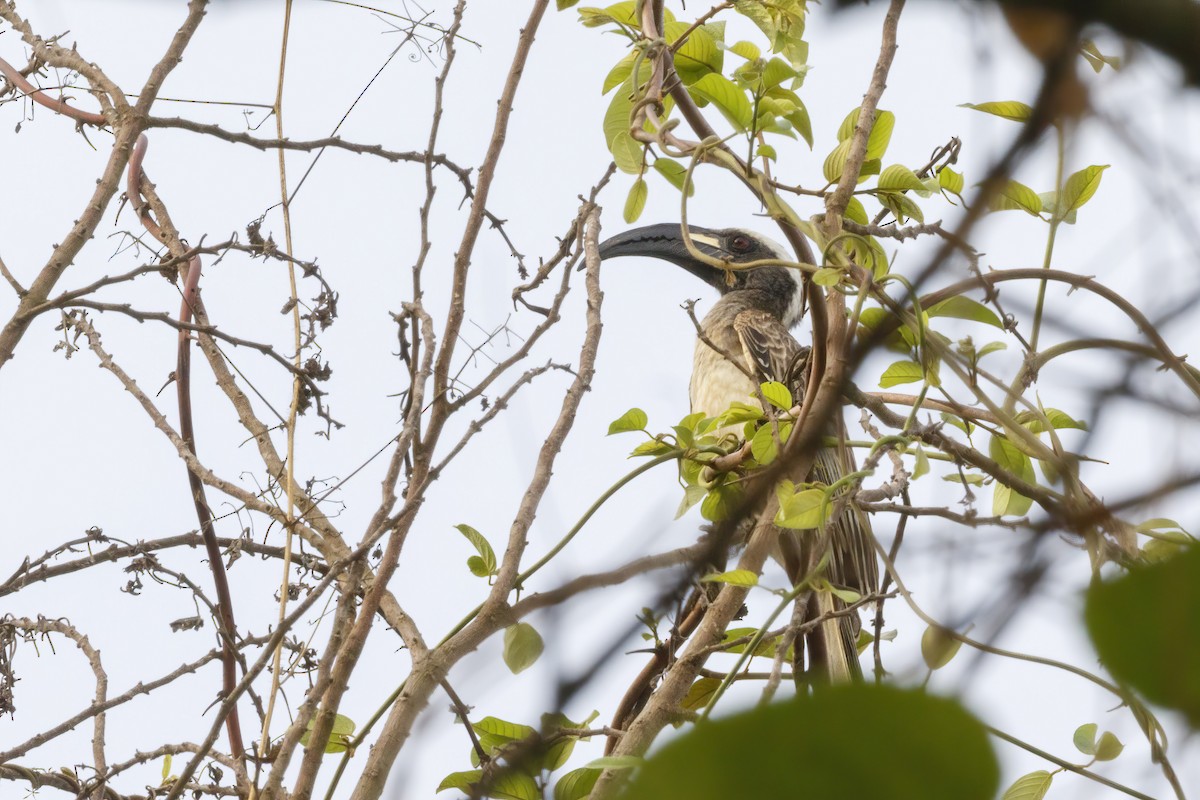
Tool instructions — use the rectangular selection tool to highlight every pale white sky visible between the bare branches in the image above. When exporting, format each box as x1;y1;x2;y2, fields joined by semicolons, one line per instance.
0;0;1200;800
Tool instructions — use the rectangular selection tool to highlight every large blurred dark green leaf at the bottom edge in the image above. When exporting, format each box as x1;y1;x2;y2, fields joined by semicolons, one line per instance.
624;685;1000;800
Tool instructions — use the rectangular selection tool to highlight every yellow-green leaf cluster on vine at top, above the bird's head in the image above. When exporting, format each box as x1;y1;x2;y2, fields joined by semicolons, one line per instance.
571;0;812;222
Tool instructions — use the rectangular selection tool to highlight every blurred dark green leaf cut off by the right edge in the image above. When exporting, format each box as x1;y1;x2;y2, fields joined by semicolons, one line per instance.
1085;547;1200;728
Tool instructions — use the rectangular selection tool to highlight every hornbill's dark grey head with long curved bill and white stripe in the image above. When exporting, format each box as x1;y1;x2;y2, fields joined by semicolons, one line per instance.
600;222;804;327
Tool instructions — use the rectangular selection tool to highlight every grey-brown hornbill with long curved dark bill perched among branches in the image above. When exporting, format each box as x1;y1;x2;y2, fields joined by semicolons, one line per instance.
600;223;878;681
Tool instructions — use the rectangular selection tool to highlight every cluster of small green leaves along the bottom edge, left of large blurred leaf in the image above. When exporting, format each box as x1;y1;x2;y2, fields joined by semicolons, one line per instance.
437;711;614;800
